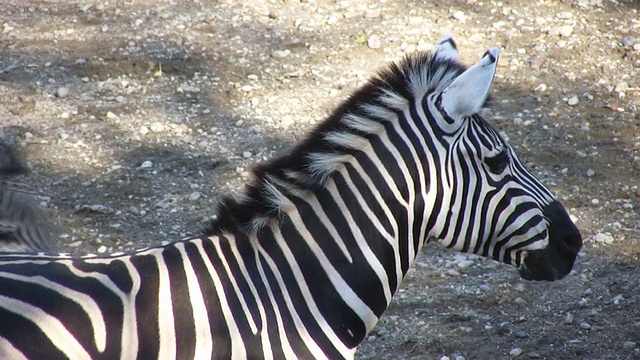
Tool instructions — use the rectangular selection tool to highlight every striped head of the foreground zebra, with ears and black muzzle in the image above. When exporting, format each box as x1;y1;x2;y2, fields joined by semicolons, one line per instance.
418;36;582;280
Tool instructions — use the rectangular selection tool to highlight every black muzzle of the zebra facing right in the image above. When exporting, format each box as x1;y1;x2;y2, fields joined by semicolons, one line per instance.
519;201;582;281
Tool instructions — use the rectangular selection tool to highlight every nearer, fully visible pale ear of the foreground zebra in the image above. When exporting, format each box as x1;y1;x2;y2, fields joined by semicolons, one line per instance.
440;48;498;119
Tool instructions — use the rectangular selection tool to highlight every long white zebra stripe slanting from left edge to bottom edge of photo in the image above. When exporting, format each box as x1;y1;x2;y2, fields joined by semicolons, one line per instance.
0;295;91;360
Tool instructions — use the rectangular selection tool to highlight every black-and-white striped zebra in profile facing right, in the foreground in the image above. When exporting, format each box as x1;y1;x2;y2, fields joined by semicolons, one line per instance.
0;36;582;359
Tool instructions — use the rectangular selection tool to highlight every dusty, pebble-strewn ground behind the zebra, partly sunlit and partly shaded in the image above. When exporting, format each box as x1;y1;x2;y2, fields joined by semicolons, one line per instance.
0;0;640;360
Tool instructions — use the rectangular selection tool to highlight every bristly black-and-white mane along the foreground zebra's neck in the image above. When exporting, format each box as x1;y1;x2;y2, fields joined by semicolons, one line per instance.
203;52;466;236
